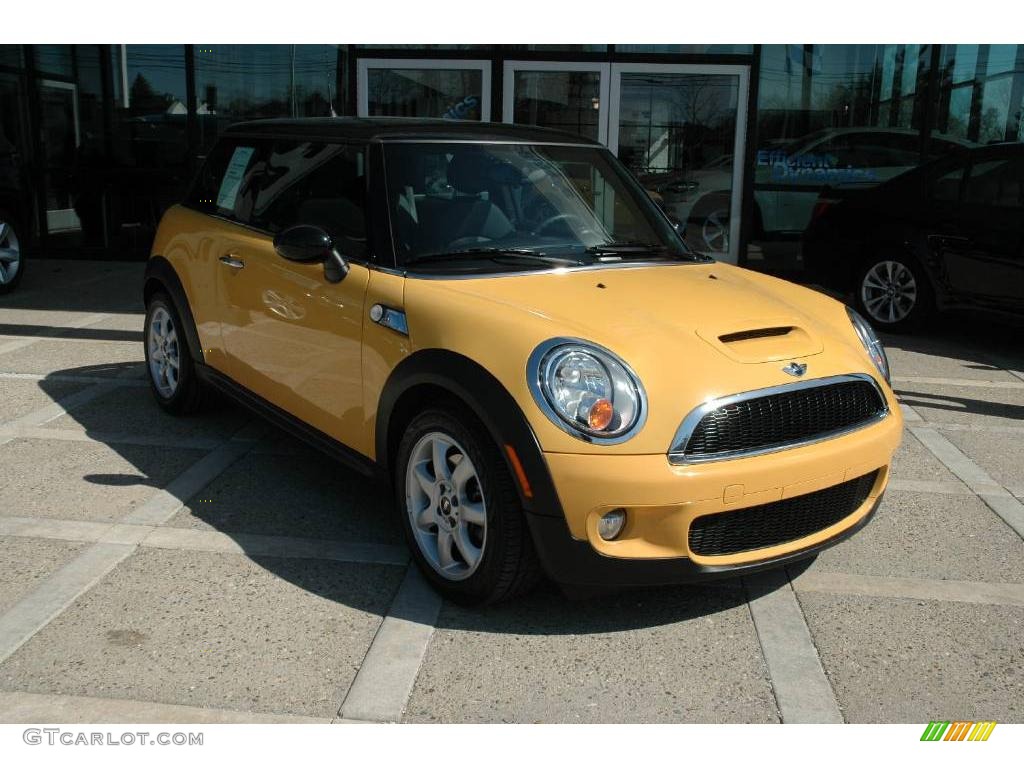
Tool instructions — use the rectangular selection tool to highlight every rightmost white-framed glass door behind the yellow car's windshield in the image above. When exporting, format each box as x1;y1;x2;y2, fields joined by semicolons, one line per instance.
607;63;749;263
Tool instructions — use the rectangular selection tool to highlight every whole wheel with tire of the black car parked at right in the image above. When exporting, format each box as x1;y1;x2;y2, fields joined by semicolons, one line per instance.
853;253;935;334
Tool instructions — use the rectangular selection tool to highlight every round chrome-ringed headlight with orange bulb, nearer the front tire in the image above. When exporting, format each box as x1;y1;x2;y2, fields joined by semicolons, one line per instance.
526;339;647;444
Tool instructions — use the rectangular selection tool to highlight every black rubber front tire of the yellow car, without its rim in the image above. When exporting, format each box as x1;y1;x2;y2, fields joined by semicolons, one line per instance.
392;404;543;605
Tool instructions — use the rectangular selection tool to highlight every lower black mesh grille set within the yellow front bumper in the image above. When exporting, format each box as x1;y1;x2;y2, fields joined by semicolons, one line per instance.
689;470;878;556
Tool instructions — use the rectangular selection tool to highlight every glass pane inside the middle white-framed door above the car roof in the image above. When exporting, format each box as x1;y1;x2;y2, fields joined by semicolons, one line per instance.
512;70;601;141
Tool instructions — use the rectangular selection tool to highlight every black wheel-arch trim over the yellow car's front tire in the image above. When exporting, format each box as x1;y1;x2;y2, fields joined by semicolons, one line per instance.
376;349;565;521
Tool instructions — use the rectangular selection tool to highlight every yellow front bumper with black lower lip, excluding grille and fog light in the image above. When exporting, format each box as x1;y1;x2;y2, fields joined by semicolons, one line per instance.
527;411;902;586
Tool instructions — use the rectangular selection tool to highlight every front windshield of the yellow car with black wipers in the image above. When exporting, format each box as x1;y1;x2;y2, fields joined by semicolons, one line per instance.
385;142;703;271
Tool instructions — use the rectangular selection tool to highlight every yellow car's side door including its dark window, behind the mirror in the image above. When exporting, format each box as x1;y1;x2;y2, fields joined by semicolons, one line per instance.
219;140;370;451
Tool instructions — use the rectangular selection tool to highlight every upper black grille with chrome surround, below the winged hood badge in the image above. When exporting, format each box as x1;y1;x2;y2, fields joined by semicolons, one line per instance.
683;380;886;459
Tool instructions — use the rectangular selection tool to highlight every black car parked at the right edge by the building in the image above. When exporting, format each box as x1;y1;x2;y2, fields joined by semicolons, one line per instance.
804;143;1024;331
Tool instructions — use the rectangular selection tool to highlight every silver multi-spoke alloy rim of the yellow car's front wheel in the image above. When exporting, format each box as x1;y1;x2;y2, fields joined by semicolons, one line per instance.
406;432;487;582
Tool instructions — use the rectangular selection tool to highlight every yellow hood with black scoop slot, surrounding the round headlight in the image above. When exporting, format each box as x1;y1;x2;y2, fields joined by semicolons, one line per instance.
404;262;871;454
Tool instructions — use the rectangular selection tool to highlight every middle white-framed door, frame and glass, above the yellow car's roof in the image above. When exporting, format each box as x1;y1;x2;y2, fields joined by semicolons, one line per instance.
502;61;610;143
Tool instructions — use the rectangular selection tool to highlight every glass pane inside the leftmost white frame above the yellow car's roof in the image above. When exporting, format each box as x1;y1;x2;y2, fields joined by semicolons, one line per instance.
366;61;484;120
